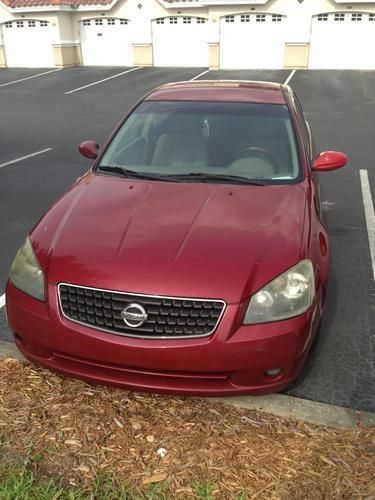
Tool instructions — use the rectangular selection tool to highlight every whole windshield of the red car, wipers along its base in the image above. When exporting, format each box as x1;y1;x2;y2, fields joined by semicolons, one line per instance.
98;101;301;184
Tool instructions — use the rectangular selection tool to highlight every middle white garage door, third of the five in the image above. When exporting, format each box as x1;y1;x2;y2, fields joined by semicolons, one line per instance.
152;16;212;67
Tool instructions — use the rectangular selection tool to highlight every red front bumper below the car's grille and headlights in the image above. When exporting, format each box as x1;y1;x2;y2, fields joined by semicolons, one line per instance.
6;282;321;396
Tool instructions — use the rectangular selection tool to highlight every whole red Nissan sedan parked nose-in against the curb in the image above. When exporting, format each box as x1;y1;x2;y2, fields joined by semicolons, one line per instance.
6;81;347;396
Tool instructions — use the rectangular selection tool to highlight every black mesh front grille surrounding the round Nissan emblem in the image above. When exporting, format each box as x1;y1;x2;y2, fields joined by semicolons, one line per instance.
59;284;225;338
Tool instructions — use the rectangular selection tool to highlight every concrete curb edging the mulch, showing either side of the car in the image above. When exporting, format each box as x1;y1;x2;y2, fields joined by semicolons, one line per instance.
0;341;375;427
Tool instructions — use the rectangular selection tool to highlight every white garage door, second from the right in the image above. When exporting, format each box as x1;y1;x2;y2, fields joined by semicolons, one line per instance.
220;14;286;69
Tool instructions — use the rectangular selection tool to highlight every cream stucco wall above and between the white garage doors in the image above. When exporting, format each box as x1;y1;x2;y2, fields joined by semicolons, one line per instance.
0;0;375;50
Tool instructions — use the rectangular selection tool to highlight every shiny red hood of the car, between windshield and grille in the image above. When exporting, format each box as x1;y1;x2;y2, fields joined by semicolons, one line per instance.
31;174;305;302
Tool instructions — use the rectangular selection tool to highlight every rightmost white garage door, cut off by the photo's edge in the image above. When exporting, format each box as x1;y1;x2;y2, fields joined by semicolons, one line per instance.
309;12;375;69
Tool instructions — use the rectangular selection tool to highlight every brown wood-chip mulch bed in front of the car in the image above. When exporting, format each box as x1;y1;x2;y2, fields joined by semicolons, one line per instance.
0;359;375;500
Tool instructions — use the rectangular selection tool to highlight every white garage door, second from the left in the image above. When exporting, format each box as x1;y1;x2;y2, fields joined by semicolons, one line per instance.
81;18;133;66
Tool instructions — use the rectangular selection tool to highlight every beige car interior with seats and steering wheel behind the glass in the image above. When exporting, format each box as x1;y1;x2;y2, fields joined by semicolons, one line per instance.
102;102;298;179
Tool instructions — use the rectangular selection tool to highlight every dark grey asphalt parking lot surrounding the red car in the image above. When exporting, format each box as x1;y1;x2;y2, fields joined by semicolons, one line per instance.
0;68;375;411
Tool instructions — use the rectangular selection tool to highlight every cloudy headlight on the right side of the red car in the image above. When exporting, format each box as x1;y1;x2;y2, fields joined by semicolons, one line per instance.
244;260;315;325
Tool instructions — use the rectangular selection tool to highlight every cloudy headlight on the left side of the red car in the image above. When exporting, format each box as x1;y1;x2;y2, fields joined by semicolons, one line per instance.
9;238;45;300
